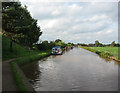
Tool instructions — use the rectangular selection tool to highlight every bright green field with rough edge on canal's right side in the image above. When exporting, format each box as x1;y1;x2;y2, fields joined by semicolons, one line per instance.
81;47;120;61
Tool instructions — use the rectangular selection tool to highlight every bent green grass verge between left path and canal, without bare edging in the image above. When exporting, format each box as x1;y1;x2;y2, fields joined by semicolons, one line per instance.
10;50;51;91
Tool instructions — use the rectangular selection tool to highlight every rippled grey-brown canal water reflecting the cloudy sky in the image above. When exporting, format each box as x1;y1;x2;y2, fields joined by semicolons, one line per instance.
21;48;118;91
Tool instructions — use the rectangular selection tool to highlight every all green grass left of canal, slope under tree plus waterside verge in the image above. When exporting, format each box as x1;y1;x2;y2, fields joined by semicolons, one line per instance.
2;35;51;91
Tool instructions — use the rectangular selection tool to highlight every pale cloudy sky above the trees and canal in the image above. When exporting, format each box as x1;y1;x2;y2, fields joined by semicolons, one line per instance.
20;0;118;44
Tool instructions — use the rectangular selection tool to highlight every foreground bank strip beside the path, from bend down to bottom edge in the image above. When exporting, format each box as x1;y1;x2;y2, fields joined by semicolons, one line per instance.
10;62;35;92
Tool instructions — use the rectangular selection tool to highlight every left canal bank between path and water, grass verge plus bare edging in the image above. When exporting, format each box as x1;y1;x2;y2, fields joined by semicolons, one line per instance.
10;52;51;93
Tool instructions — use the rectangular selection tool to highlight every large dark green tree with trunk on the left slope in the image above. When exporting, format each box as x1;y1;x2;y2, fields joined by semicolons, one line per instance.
2;2;42;51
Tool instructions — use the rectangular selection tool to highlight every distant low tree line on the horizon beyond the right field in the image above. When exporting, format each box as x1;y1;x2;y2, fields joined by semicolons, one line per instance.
77;40;120;47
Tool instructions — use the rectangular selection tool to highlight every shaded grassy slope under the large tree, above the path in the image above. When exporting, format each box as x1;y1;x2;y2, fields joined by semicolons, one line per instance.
2;35;43;61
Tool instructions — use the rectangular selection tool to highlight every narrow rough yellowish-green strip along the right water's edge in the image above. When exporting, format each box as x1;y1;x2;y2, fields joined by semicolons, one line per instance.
80;47;120;62
